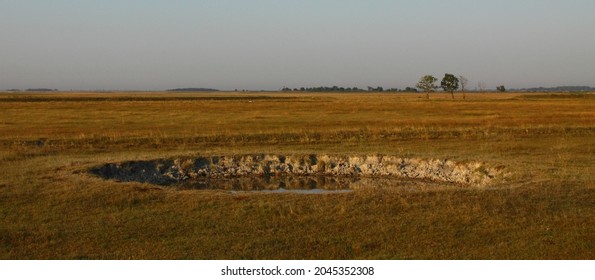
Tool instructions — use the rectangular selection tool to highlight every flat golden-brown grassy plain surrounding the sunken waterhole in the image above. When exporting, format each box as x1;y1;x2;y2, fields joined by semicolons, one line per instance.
0;93;595;259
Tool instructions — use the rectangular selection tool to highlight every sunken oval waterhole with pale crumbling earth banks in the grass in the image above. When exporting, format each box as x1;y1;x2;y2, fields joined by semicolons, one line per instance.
90;154;504;190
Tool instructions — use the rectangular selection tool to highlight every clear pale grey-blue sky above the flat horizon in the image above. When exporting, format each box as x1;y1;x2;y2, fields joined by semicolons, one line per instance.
0;0;595;90
